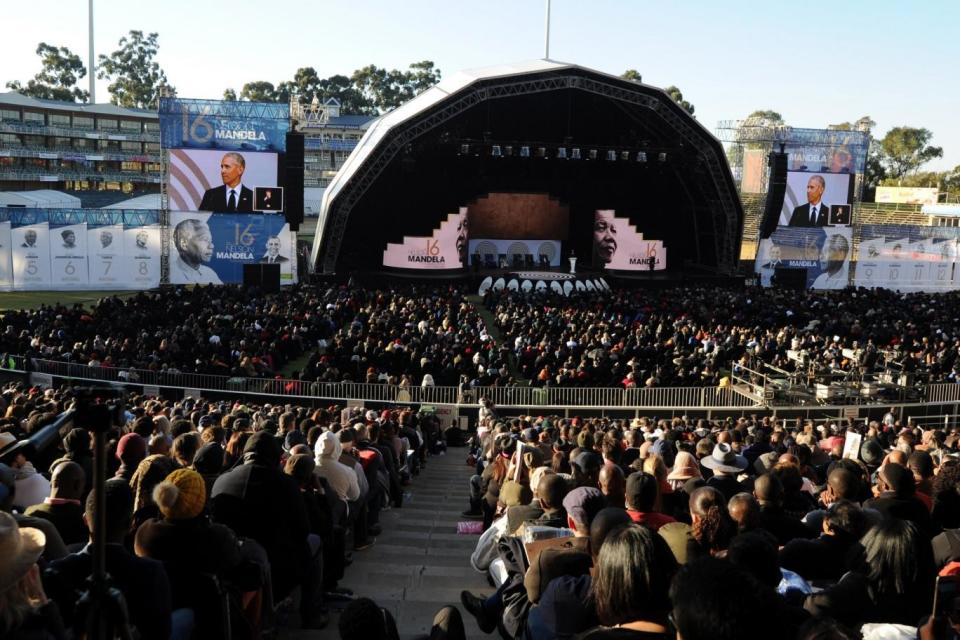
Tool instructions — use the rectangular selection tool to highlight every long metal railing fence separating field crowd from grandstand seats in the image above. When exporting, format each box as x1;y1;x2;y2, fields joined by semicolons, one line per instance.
0;355;960;424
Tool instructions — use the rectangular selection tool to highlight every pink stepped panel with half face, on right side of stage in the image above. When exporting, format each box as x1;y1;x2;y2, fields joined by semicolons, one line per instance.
593;209;667;271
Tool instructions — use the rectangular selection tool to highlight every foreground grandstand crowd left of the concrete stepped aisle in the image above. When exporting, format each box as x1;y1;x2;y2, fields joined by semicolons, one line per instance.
0;383;444;640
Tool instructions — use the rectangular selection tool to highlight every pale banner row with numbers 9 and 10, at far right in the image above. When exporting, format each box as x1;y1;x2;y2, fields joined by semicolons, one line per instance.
854;225;960;292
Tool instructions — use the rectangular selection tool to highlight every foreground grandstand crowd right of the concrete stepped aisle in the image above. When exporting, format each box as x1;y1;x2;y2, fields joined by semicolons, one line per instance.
461;407;960;640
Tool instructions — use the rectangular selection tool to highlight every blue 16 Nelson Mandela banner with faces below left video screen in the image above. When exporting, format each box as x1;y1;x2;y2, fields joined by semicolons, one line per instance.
169;211;296;284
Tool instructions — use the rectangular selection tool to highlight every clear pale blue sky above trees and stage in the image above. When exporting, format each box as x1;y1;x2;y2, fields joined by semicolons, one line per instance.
0;0;960;169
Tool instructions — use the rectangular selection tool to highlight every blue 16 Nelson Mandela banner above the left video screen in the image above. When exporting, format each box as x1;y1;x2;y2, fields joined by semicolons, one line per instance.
159;98;290;152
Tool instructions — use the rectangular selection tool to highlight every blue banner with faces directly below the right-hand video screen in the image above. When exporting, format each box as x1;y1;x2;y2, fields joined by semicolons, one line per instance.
756;226;853;289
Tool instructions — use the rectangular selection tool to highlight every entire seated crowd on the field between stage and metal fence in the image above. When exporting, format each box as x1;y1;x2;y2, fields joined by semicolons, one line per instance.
0;284;960;394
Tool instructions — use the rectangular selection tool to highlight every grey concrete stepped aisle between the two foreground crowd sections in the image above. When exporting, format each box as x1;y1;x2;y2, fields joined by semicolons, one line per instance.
284;448;492;640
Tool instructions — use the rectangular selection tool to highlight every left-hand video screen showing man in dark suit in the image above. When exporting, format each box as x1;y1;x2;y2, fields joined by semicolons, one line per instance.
168;149;277;213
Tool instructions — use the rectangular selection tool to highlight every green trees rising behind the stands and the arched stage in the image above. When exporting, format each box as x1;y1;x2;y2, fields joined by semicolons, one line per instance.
7;35;960;198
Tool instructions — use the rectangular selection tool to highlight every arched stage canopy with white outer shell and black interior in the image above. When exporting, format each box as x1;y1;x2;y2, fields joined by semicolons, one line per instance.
312;59;743;275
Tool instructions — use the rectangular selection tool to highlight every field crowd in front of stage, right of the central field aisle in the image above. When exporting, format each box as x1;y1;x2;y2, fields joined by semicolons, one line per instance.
484;286;960;388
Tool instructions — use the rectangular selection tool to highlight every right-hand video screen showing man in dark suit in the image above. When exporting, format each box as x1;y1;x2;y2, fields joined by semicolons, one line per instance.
779;171;853;227
